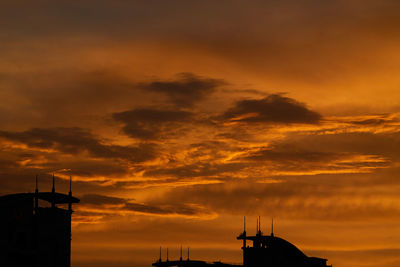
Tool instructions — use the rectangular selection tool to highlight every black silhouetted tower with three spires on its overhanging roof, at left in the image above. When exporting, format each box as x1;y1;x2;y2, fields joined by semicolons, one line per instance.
0;175;79;267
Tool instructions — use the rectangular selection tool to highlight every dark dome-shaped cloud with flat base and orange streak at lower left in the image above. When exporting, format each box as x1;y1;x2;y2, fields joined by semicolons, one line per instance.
222;94;321;124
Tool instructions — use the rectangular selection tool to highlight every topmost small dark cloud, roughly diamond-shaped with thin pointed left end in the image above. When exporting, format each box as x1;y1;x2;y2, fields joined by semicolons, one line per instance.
138;73;226;107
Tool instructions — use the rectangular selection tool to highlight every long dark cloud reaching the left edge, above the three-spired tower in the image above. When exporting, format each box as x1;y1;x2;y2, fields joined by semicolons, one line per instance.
0;127;155;162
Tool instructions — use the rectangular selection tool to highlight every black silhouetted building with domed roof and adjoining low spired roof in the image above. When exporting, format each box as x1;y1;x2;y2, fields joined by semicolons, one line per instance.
153;219;332;267
